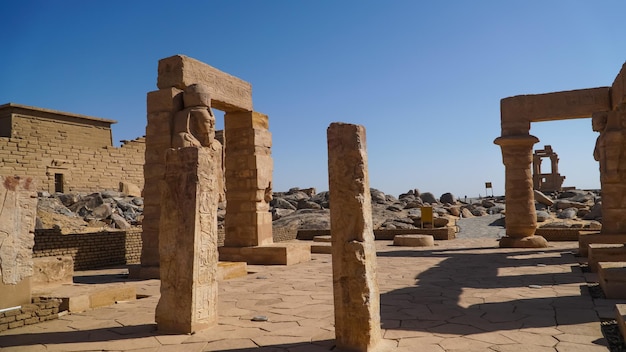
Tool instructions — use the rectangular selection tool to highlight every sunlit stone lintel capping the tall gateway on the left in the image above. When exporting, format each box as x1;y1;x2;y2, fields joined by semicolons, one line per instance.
157;55;252;112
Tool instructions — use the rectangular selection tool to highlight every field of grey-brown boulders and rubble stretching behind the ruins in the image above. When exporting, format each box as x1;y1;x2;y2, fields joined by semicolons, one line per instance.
36;188;602;233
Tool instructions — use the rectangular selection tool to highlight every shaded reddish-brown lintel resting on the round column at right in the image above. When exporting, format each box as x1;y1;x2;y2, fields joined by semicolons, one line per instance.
500;87;611;127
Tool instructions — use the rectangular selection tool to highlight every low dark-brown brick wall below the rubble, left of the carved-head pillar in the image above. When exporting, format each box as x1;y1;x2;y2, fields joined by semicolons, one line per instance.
33;229;142;270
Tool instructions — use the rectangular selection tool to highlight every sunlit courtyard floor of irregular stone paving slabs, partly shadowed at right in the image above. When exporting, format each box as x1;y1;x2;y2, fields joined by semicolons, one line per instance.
0;238;625;352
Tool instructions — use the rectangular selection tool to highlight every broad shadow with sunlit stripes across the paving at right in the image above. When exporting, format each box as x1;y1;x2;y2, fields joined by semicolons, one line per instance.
378;247;599;335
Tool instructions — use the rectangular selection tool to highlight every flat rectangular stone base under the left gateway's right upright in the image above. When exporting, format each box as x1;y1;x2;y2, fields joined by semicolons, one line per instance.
218;243;311;265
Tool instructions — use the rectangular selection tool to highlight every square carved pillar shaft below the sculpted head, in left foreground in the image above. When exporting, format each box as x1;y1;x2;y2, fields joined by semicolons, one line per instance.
156;147;222;333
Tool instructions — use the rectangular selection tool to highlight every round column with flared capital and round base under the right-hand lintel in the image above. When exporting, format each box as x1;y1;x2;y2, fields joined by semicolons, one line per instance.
494;135;547;247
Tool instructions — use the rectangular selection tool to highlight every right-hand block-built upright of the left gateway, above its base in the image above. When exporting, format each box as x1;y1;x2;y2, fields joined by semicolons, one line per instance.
224;111;274;247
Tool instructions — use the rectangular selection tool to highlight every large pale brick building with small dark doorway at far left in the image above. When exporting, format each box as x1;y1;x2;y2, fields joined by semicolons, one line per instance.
0;104;146;192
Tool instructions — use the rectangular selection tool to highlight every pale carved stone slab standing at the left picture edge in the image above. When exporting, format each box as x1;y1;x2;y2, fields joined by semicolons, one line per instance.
0;176;37;309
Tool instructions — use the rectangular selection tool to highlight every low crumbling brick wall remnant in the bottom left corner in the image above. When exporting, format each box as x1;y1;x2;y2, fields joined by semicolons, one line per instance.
0;298;61;331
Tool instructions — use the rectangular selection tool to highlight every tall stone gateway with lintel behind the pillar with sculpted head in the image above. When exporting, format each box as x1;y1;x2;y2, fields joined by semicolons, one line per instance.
131;55;310;278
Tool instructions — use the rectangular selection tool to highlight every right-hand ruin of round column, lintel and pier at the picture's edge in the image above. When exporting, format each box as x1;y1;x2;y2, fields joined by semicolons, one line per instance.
494;64;626;247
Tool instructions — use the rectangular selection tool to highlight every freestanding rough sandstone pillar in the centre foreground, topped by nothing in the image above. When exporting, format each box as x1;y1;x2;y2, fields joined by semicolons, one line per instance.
328;123;381;351
